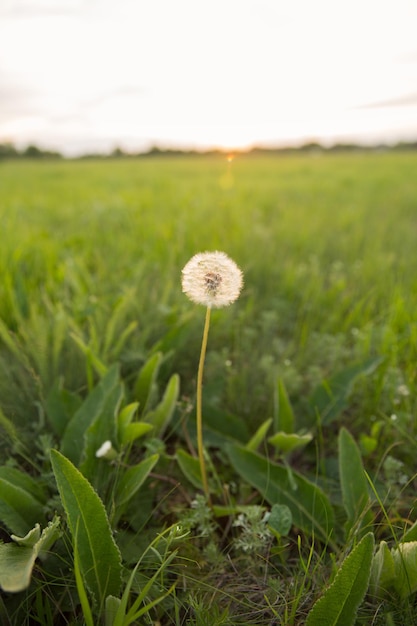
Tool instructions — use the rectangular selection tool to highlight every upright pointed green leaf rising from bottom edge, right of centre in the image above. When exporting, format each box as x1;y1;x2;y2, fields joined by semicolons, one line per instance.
306;533;374;626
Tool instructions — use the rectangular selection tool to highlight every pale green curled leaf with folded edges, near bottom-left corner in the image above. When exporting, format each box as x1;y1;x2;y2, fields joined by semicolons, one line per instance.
0;517;60;593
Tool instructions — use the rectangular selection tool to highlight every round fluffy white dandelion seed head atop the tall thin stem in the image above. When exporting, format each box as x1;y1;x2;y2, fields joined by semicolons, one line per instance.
182;251;243;308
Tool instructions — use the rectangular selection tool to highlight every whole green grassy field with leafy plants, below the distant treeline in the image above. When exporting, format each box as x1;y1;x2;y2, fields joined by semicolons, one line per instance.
0;152;417;626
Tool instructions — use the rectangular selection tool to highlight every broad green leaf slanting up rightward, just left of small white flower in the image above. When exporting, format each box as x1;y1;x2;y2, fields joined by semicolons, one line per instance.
61;365;120;465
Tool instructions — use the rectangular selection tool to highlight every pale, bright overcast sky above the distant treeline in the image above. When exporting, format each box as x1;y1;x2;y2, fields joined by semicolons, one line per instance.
0;0;417;156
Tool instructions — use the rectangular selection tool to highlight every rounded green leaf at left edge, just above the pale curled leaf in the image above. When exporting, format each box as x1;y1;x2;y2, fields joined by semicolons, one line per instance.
0;468;45;535
